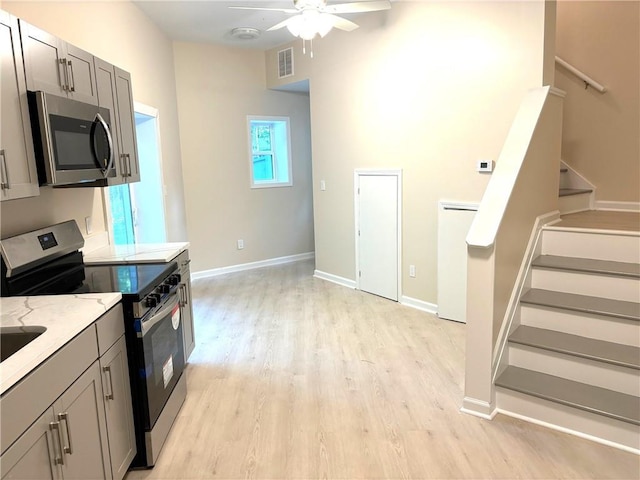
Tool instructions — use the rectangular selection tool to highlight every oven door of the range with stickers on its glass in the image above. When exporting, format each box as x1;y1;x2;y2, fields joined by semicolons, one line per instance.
137;290;185;430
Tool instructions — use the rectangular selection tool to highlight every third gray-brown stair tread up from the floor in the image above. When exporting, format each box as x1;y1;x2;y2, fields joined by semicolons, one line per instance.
520;288;640;321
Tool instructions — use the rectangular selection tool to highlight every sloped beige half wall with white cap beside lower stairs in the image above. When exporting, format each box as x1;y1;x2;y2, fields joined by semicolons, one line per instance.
462;86;564;418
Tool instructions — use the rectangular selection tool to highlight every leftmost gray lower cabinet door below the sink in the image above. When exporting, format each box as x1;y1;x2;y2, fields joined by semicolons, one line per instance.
0;408;62;480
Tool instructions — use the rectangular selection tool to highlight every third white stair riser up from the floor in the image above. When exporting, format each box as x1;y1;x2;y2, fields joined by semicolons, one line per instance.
520;304;640;347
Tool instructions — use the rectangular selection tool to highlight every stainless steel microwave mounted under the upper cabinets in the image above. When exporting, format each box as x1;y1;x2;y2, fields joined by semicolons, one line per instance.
28;91;116;186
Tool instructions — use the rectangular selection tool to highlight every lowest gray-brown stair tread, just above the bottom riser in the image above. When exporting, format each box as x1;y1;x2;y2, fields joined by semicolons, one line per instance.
496;366;640;425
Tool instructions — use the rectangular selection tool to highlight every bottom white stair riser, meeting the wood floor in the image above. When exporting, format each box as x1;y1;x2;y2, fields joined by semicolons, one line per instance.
496;387;640;453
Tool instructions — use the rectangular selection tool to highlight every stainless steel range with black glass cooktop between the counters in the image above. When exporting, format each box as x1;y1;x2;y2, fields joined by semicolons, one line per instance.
0;221;186;467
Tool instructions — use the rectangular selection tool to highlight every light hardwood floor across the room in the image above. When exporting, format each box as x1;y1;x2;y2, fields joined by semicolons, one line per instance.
126;262;640;480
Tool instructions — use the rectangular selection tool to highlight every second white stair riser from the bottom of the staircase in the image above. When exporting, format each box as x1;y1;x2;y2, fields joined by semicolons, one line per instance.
509;343;640;401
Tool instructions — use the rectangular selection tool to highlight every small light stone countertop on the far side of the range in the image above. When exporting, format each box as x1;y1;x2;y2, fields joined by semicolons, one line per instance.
84;242;189;265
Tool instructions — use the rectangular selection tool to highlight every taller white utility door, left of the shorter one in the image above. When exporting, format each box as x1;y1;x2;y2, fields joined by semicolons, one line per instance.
356;172;400;301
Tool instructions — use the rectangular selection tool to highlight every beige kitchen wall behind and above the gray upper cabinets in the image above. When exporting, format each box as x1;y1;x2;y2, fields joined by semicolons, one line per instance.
1;1;186;241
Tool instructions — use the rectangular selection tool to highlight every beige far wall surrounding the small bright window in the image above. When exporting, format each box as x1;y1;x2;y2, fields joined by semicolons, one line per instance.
174;43;314;271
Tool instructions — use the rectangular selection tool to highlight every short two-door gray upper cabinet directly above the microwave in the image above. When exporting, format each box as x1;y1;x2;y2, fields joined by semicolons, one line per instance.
20;20;98;105
